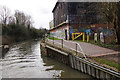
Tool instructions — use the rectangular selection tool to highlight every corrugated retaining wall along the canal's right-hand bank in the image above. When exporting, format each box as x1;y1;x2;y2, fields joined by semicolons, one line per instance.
41;39;120;80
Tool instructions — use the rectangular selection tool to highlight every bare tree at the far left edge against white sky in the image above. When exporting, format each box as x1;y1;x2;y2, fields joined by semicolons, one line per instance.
0;6;10;26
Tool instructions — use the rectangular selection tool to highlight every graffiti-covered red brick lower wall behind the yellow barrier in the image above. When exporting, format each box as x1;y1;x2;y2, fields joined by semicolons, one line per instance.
69;24;114;39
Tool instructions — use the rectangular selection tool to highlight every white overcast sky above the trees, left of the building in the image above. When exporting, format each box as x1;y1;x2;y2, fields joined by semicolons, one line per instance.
0;0;57;29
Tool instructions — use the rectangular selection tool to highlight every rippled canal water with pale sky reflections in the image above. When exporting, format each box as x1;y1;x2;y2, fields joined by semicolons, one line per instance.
0;41;91;78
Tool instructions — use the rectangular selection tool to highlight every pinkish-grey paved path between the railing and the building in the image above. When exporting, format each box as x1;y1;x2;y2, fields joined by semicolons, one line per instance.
48;40;120;57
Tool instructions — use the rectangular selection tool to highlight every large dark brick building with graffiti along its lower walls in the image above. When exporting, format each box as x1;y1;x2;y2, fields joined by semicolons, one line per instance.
50;2;113;40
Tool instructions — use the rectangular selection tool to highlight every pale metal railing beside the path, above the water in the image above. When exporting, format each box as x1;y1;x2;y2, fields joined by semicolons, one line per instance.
45;37;87;59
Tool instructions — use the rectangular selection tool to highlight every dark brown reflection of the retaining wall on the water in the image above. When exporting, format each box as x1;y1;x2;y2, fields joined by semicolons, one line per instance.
41;55;91;78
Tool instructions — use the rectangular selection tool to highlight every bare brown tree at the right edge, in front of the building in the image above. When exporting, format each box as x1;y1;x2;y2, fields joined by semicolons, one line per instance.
92;2;120;44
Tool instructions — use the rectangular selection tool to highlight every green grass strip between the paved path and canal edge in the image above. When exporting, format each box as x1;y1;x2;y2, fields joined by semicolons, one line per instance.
93;57;120;70
